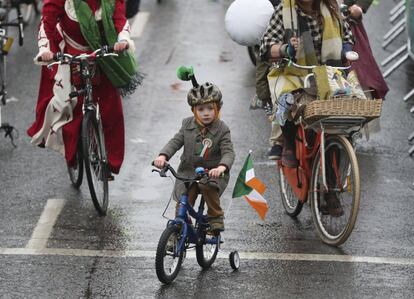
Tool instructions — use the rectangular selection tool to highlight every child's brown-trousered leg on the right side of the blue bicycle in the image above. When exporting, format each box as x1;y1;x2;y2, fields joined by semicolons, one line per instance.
198;184;224;231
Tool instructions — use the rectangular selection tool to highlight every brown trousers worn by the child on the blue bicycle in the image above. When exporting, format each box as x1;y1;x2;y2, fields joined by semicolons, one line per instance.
176;184;224;218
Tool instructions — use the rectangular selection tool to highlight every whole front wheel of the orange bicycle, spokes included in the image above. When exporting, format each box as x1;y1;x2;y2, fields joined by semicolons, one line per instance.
310;135;361;246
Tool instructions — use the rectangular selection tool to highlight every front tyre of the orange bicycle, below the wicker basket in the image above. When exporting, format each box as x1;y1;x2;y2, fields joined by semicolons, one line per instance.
310;135;361;246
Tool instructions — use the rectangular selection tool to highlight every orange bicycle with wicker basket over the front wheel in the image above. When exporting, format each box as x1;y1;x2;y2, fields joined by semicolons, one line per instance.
277;58;382;246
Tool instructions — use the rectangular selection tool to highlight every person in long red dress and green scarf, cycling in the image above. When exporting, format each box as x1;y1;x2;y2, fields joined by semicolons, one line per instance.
27;0;140;174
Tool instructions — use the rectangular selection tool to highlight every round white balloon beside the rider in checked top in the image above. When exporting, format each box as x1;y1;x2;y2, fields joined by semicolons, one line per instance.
224;0;274;46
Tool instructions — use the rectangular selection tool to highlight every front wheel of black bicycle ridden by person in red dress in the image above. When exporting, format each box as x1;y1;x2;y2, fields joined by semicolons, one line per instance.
82;111;109;216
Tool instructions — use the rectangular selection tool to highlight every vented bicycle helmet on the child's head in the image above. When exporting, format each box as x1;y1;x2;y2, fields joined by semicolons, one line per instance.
187;82;223;109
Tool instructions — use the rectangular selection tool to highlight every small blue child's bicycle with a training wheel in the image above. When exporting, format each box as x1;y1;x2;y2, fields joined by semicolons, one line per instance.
152;164;240;284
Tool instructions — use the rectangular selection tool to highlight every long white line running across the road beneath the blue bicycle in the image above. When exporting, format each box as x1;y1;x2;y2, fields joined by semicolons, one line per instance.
0;248;414;266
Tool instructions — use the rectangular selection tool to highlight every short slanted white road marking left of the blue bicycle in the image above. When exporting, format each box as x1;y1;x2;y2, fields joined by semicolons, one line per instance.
26;199;65;250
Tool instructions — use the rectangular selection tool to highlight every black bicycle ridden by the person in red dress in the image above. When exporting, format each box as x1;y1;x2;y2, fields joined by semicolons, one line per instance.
42;46;118;216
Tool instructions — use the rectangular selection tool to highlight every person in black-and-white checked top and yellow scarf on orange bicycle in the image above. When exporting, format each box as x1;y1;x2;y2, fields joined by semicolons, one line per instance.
260;0;353;168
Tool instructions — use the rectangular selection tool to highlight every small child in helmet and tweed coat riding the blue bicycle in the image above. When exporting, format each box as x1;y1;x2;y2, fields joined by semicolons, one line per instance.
154;70;235;233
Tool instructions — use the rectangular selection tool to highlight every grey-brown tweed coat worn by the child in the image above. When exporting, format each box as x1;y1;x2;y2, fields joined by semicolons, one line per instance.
160;117;235;198
